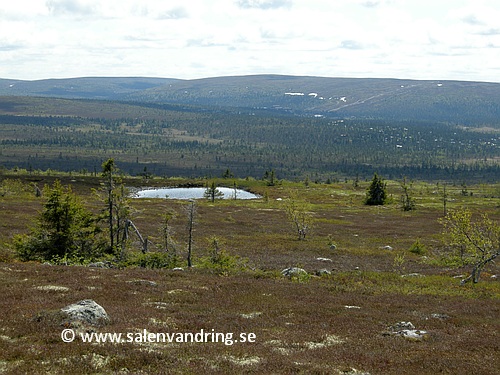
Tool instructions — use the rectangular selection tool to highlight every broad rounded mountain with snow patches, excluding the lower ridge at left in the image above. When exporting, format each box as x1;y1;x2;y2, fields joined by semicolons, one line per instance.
129;75;500;125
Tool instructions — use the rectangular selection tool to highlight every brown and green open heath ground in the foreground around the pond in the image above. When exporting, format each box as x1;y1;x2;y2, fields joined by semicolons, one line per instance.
0;172;500;375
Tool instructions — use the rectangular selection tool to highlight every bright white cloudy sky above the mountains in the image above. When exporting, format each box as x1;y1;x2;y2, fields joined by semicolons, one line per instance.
0;0;500;82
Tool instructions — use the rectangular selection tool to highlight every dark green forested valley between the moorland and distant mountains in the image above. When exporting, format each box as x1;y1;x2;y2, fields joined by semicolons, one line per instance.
0;97;500;182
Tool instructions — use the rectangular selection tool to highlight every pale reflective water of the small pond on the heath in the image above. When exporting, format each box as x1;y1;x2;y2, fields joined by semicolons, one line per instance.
134;187;260;199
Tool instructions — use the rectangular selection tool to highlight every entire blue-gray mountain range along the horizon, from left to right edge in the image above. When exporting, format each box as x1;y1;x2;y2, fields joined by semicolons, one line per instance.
0;75;500;128
